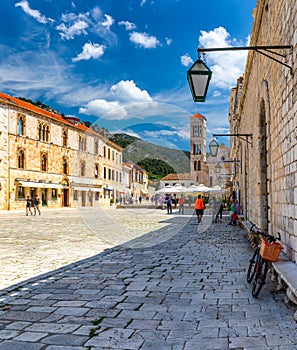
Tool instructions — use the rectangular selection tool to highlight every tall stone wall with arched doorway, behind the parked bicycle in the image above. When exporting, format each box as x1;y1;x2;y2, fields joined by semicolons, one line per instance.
229;0;297;263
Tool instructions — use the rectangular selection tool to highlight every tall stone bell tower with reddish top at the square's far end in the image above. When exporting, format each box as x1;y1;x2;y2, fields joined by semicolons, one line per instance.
190;114;209;186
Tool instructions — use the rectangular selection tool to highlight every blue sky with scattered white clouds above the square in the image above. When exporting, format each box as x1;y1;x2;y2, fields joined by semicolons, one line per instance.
0;0;256;149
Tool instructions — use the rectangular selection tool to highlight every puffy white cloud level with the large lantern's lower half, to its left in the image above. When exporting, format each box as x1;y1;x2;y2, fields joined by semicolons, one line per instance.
110;80;152;103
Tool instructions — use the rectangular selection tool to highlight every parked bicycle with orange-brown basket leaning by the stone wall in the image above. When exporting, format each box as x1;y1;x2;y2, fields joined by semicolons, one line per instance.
246;225;283;298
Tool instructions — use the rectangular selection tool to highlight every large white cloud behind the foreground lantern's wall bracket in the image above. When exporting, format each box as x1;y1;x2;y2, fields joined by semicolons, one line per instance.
199;27;247;89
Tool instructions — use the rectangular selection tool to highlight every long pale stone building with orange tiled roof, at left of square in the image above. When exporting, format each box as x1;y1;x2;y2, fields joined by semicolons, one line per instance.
0;93;122;210
